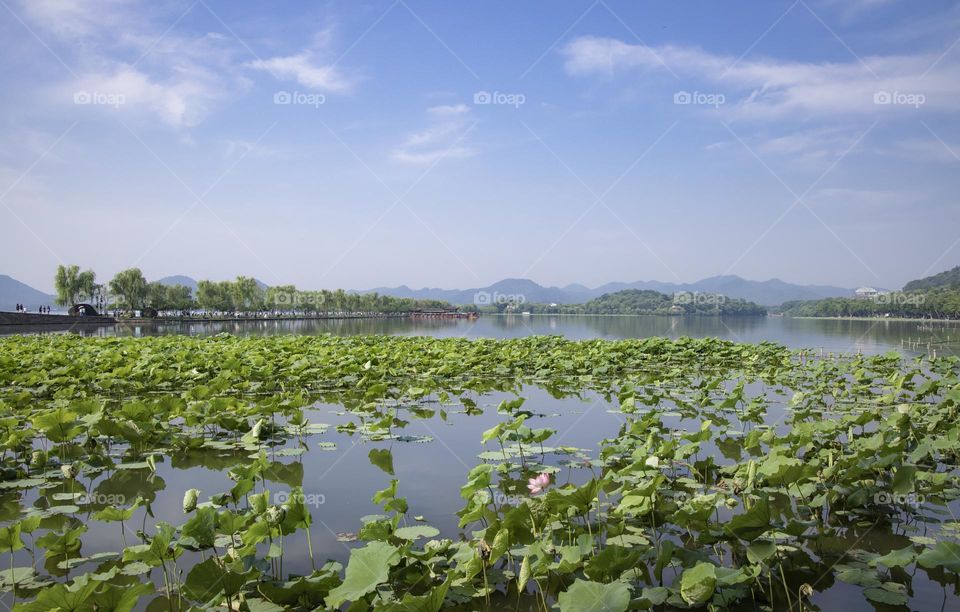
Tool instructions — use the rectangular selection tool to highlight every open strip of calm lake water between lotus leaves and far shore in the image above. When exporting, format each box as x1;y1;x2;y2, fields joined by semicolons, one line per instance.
0;315;960;355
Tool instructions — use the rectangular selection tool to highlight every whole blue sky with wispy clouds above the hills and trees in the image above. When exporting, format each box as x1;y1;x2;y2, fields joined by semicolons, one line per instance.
0;0;960;289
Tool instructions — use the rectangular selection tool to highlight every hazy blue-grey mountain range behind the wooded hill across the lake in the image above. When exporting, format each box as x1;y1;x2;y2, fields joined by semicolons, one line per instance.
359;275;853;306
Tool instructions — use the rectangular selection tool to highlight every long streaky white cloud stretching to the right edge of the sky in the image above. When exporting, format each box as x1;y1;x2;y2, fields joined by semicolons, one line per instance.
561;36;960;119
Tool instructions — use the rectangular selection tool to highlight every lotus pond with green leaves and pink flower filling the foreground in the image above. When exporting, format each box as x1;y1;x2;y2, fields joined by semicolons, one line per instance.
0;336;960;612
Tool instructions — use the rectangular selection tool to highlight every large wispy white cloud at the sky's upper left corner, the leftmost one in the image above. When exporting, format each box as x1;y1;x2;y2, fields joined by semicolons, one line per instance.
22;0;249;129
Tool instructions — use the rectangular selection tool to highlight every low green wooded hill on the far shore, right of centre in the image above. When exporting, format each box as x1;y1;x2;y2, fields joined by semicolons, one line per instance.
499;289;767;316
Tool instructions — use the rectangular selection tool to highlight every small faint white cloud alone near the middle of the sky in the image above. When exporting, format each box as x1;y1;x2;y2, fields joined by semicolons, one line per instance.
391;104;476;165
